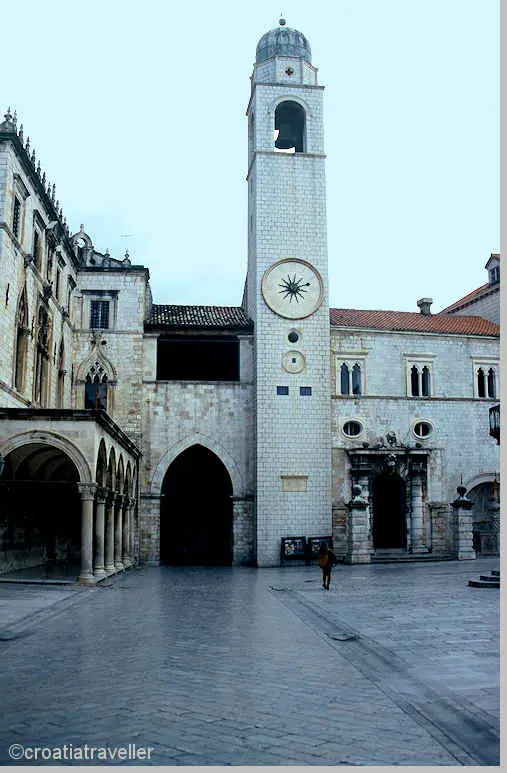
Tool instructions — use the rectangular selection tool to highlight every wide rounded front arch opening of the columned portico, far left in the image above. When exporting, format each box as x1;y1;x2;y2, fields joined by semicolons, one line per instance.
0;442;81;573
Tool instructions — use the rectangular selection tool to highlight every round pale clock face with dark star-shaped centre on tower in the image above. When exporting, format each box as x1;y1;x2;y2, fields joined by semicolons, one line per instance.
262;258;323;319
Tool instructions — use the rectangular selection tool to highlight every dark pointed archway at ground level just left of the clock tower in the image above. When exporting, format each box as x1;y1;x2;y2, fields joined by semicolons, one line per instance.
160;445;233;566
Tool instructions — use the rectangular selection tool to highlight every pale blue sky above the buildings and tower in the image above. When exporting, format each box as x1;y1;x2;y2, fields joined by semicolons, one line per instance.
0;0;500;311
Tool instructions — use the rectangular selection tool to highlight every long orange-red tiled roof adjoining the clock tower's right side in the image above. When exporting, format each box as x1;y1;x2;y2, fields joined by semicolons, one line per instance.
329;309;500;336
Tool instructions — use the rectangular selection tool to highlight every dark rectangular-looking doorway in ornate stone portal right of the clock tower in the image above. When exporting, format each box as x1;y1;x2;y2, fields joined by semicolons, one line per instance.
373;472;406;550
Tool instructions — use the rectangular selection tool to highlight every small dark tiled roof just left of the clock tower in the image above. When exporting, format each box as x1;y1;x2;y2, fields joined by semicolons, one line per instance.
147;303;253;331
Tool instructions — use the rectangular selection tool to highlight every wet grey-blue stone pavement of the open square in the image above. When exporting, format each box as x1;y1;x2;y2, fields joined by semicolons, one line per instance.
0;559;499;766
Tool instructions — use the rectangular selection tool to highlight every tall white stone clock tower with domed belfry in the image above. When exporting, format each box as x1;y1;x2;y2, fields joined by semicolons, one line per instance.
245;19;332;566
